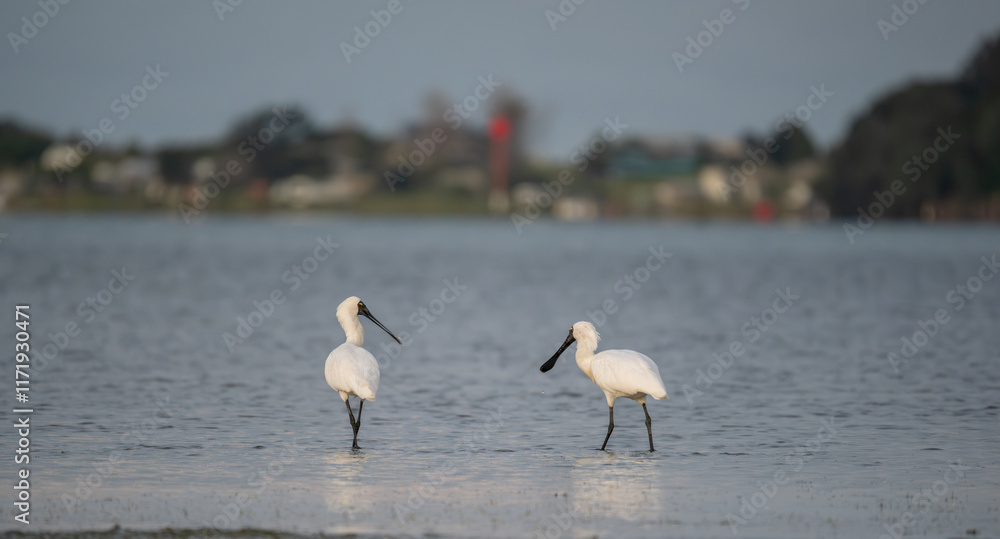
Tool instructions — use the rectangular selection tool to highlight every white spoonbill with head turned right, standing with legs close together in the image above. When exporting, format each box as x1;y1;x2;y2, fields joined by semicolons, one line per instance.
325;296;403;449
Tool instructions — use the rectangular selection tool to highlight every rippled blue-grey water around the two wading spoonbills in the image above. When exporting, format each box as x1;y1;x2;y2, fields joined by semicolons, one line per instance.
0;216;1000;539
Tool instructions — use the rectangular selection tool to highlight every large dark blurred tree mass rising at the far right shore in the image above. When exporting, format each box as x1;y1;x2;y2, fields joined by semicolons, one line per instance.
821;32;1000;218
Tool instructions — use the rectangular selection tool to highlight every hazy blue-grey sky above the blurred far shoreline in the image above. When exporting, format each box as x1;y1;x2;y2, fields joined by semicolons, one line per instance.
0;0;1000;159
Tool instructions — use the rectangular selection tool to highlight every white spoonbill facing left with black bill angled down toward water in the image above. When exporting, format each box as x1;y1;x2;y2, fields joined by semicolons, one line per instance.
541;322;667;451
